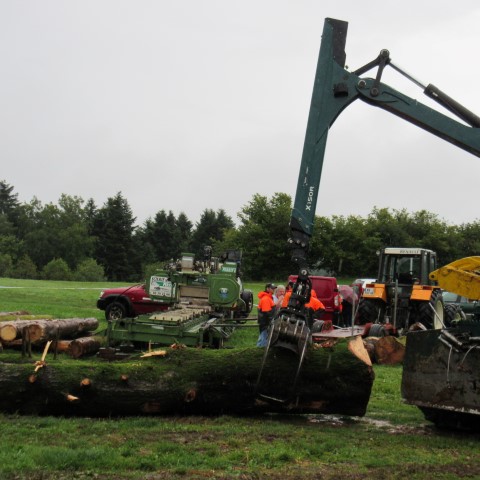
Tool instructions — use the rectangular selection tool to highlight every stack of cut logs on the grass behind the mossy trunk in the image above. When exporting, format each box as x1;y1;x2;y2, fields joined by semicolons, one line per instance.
0;318;101;358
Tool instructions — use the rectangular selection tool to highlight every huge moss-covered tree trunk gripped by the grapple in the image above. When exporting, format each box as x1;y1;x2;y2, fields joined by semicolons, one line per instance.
0;337;374;416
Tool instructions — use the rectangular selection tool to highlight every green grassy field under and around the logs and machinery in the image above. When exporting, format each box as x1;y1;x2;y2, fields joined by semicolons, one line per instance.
0;279;480;480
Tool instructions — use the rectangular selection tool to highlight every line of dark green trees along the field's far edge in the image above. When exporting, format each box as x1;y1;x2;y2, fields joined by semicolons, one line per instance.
0;180;480;282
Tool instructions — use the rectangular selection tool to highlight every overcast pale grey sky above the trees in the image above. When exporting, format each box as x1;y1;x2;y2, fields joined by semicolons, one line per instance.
0;0;480;228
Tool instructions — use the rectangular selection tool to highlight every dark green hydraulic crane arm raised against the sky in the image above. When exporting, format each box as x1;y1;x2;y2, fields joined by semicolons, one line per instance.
289;18;480;268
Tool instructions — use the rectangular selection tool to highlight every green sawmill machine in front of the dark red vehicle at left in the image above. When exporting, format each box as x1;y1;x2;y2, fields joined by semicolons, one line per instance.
107;249;253;348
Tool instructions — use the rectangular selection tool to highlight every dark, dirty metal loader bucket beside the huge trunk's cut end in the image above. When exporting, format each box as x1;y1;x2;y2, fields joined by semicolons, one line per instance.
402;322;480;431
